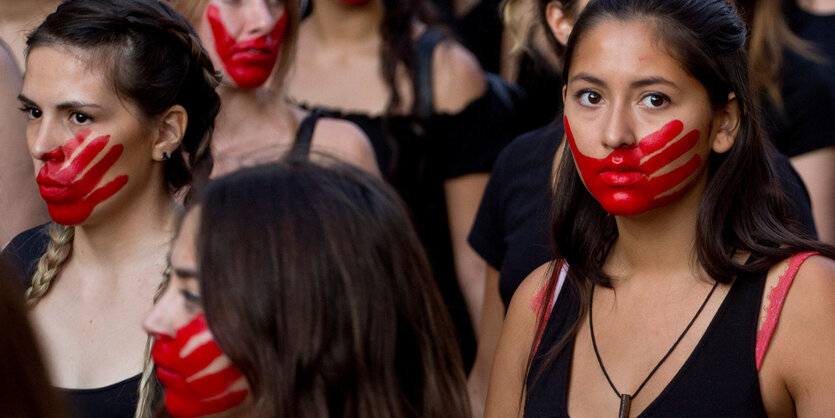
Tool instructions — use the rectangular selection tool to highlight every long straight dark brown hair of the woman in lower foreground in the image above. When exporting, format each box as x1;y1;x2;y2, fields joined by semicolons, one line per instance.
197;156;469;418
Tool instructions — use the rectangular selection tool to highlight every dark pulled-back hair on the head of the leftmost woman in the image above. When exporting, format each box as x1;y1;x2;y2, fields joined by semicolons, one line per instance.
26;0;220;192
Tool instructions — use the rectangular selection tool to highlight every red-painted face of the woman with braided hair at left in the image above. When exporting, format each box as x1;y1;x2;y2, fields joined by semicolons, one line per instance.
19;46;158;225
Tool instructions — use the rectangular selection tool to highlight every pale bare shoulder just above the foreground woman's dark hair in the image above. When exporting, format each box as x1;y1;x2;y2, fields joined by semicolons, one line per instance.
312;118;380;176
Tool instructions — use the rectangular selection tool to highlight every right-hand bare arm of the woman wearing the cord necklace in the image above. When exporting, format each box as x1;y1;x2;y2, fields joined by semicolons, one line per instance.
760;256;835;418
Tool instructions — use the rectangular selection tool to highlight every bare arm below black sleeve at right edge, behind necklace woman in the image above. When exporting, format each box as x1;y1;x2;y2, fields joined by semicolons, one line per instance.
791;146;835;244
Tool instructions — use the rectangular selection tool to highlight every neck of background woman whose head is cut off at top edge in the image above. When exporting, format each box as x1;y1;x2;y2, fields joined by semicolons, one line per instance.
310;0;384;45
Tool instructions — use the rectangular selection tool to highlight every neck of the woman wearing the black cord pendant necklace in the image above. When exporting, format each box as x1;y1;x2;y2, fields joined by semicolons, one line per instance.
606;176;705;281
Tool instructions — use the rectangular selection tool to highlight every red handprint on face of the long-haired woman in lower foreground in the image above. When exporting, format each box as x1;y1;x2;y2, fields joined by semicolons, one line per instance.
151;313;249;418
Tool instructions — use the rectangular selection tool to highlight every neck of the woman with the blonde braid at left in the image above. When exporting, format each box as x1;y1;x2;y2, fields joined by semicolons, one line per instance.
72;181;179;276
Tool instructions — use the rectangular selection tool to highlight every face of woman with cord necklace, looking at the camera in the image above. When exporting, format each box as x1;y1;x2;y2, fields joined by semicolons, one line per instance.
563;19;723;216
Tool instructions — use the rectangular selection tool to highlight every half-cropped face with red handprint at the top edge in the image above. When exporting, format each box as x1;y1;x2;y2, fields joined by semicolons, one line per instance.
196;0;287;89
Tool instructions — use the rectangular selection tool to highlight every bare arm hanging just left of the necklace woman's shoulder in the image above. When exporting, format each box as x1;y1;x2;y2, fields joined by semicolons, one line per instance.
467;266;504;417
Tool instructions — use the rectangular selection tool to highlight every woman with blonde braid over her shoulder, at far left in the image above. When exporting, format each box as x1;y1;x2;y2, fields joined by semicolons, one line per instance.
4;0;220;417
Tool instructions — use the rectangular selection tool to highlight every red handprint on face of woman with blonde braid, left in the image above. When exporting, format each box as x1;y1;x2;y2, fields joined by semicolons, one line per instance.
37;130;128;225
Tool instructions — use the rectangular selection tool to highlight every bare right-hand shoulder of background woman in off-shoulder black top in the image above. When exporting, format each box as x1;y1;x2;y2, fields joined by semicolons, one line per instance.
432;39;487;113
